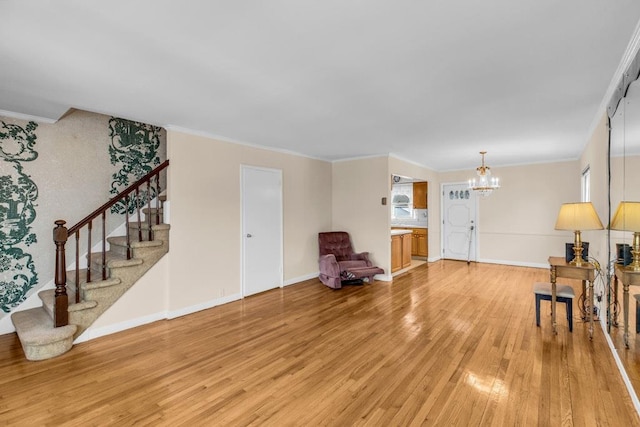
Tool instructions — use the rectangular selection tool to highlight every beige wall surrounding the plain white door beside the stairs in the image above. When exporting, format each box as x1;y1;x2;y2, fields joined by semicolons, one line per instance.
167;130;332;312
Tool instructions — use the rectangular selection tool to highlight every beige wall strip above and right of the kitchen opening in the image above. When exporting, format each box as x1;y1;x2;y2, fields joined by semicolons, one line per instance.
389;156;442;261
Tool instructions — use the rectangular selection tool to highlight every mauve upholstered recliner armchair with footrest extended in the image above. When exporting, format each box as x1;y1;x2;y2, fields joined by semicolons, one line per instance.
318;231;384;289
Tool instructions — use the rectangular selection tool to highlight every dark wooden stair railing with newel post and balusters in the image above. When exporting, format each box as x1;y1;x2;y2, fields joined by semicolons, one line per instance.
53;160;169;328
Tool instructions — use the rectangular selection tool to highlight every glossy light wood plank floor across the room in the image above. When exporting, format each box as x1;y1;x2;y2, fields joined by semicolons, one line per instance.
0;261;640;426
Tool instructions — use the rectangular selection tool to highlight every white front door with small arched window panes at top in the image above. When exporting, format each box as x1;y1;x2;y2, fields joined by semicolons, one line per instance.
442;183;478;261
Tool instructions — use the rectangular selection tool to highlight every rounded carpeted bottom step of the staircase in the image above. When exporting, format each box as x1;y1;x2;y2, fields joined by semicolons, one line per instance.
11;307;77;360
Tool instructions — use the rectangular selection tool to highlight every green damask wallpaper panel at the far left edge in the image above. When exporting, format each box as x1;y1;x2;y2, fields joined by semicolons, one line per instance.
0;121;38;313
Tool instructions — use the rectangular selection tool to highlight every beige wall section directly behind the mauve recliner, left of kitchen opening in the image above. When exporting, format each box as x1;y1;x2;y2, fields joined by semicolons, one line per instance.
332;156;391;279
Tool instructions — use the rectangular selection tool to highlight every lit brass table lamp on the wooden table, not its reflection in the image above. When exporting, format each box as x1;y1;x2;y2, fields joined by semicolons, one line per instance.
555;202;604;267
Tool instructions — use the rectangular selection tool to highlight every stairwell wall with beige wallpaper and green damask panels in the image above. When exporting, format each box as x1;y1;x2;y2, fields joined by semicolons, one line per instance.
0;110;166;322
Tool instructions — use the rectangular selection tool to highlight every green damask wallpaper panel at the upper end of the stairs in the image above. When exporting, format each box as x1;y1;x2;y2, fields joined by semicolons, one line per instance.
109;117;162;213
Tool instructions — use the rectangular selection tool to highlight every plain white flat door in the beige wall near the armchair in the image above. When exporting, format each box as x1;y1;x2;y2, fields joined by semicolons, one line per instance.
242;166;283;296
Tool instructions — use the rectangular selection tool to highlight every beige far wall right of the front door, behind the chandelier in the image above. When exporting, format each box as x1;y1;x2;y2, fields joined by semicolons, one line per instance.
440;161;580;267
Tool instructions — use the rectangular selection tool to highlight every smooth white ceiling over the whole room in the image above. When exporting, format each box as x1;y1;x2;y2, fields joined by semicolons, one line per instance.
0;0;640;171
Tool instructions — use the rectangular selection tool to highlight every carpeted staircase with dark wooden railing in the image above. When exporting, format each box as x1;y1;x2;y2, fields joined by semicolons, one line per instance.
11;161;170;360
